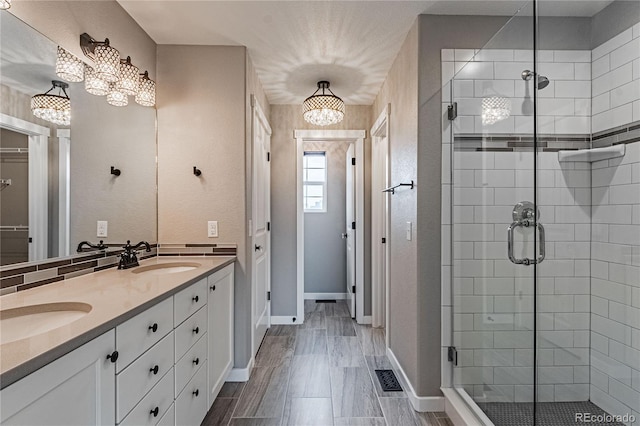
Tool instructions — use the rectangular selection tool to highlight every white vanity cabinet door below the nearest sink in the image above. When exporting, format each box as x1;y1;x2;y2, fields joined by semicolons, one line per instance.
0;330;116;426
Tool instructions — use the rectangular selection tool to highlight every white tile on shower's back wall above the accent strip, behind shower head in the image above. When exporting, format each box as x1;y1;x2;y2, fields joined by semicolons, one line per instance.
442;49;592;135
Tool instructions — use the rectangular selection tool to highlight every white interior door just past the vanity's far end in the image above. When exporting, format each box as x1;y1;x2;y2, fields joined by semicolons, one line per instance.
250;97;271;356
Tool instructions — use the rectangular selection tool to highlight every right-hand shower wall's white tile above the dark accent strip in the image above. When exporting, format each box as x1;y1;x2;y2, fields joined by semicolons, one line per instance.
591;25;640;133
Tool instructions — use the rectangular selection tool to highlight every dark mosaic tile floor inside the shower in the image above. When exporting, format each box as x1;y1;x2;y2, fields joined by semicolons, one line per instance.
478;401;624;426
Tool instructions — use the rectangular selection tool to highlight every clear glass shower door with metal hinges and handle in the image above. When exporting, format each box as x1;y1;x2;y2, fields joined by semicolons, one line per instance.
450;3;548;426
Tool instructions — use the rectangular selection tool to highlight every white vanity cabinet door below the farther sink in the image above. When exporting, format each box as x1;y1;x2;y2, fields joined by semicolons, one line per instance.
207;264;234;407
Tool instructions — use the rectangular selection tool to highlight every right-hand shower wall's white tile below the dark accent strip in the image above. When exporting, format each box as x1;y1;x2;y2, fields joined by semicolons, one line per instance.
590;141;640;420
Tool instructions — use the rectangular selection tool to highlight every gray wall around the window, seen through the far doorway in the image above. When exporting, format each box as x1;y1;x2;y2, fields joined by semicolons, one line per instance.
304;142;349;293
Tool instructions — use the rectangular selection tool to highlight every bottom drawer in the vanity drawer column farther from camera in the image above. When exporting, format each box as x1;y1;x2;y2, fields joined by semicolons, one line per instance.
176;361;207;426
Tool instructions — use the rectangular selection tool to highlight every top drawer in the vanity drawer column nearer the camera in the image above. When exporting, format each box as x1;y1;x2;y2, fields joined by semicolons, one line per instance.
116;297;173;372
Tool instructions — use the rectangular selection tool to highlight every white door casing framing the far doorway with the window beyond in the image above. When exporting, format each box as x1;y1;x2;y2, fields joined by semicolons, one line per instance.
295;130;366;322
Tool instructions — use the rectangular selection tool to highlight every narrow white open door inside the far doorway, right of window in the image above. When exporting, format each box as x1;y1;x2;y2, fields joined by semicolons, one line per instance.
345;144;356;318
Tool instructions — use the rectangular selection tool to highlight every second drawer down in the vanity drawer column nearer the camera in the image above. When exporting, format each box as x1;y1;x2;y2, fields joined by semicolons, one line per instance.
116;333;174;421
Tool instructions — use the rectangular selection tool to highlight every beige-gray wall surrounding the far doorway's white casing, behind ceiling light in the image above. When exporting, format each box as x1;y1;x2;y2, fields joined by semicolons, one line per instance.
270;105;372;316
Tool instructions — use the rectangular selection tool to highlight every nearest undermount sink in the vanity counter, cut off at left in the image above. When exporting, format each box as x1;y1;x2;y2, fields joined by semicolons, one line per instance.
0;302;91;345
